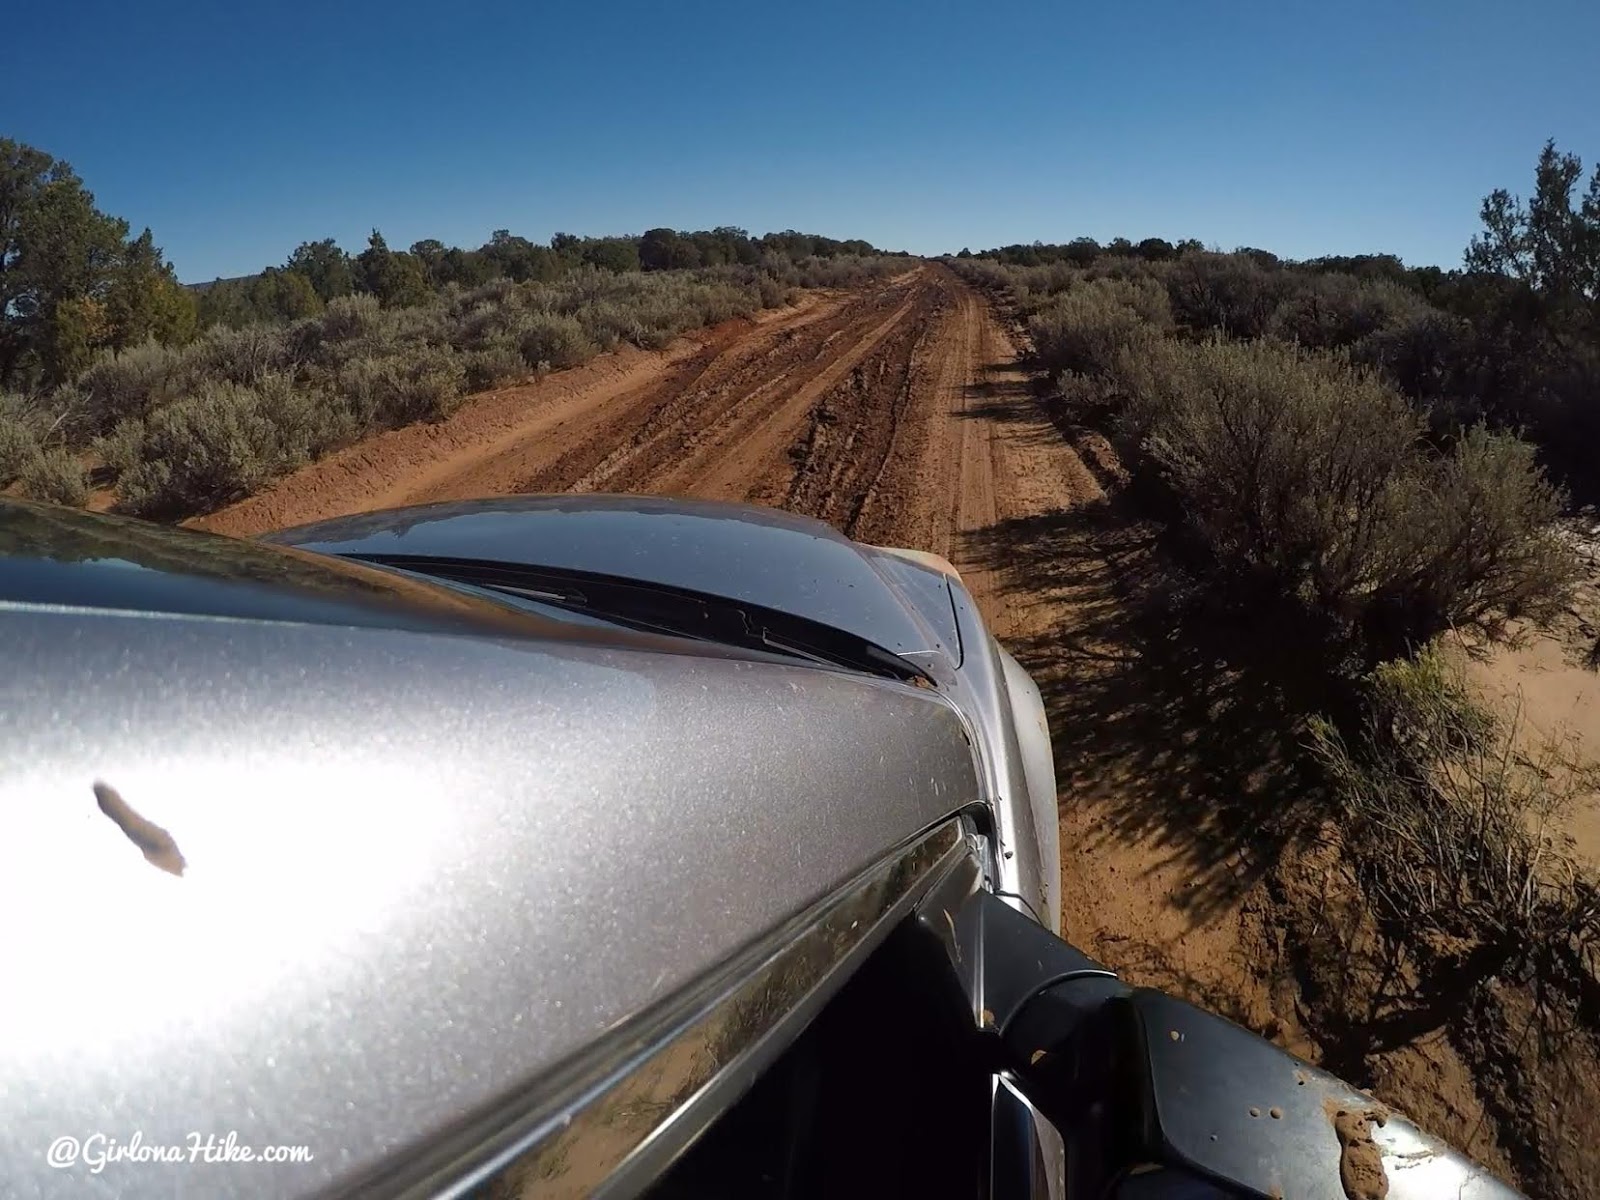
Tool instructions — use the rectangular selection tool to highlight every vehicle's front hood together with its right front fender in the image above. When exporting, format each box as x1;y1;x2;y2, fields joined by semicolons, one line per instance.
266;494;1061;928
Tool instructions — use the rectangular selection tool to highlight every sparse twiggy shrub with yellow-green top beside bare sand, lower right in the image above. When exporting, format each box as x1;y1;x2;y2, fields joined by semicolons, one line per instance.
1312;646;1600;1005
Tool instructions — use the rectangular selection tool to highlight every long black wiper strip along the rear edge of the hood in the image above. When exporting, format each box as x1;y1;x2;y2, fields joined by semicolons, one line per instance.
347;554;931;682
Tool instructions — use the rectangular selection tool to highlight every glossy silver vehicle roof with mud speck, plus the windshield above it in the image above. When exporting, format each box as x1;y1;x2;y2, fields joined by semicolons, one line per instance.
0;507;981;1197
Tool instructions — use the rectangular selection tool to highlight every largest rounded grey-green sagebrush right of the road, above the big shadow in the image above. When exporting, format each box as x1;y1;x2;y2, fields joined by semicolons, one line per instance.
1115;341;1573;667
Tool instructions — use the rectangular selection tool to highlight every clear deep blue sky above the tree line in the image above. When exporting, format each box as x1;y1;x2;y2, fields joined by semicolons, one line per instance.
0;0;1600;280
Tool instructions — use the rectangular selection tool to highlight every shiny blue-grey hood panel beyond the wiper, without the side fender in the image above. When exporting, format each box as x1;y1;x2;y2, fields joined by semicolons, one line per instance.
262;494;958;672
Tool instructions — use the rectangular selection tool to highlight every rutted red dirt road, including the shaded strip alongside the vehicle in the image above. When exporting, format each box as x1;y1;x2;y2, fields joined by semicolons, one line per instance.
194;266;1561;1196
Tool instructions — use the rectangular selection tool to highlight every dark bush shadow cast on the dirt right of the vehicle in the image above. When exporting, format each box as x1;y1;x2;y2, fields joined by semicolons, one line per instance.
963;498;1338;920
